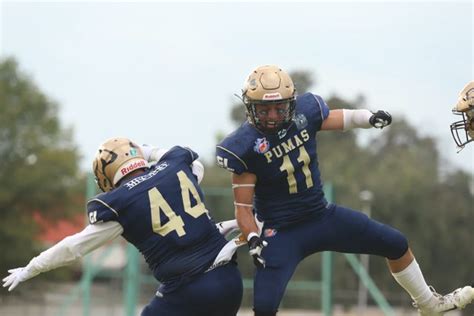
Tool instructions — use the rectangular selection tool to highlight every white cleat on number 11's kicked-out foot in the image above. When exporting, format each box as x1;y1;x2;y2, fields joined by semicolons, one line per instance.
413;286;474;316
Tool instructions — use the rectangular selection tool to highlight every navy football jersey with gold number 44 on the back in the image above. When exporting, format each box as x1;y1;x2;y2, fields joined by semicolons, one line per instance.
87;147;226;292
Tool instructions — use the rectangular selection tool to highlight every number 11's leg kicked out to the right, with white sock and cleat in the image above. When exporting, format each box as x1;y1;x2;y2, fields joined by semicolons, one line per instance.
318;206;474;311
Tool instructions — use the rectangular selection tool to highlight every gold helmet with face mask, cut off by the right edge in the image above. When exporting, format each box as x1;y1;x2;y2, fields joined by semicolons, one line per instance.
451;81;474;148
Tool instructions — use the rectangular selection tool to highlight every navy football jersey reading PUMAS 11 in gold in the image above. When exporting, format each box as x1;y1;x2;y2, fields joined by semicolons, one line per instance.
216;93;329;227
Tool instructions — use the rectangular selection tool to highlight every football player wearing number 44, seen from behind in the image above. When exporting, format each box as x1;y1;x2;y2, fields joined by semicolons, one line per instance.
3;138;243;316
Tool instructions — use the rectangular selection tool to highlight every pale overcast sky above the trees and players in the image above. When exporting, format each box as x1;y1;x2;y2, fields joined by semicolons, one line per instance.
0;0;474;172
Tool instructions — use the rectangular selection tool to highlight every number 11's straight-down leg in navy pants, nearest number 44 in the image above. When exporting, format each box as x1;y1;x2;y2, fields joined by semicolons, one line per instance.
254;226;303;316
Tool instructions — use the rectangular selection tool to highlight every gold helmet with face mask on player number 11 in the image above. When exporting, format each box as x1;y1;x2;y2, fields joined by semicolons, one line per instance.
242;65;296;132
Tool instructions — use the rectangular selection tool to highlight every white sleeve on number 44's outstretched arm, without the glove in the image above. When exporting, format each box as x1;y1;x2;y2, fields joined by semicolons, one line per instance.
26;222;123;277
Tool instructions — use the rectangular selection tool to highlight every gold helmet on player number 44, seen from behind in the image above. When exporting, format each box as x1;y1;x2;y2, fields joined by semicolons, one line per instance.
92;137;147;192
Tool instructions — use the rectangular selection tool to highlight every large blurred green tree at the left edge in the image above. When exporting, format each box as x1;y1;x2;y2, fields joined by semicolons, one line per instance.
0;58;84;282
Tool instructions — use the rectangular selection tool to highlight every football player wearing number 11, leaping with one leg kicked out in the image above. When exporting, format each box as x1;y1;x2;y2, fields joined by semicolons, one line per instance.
216;66;474;316
